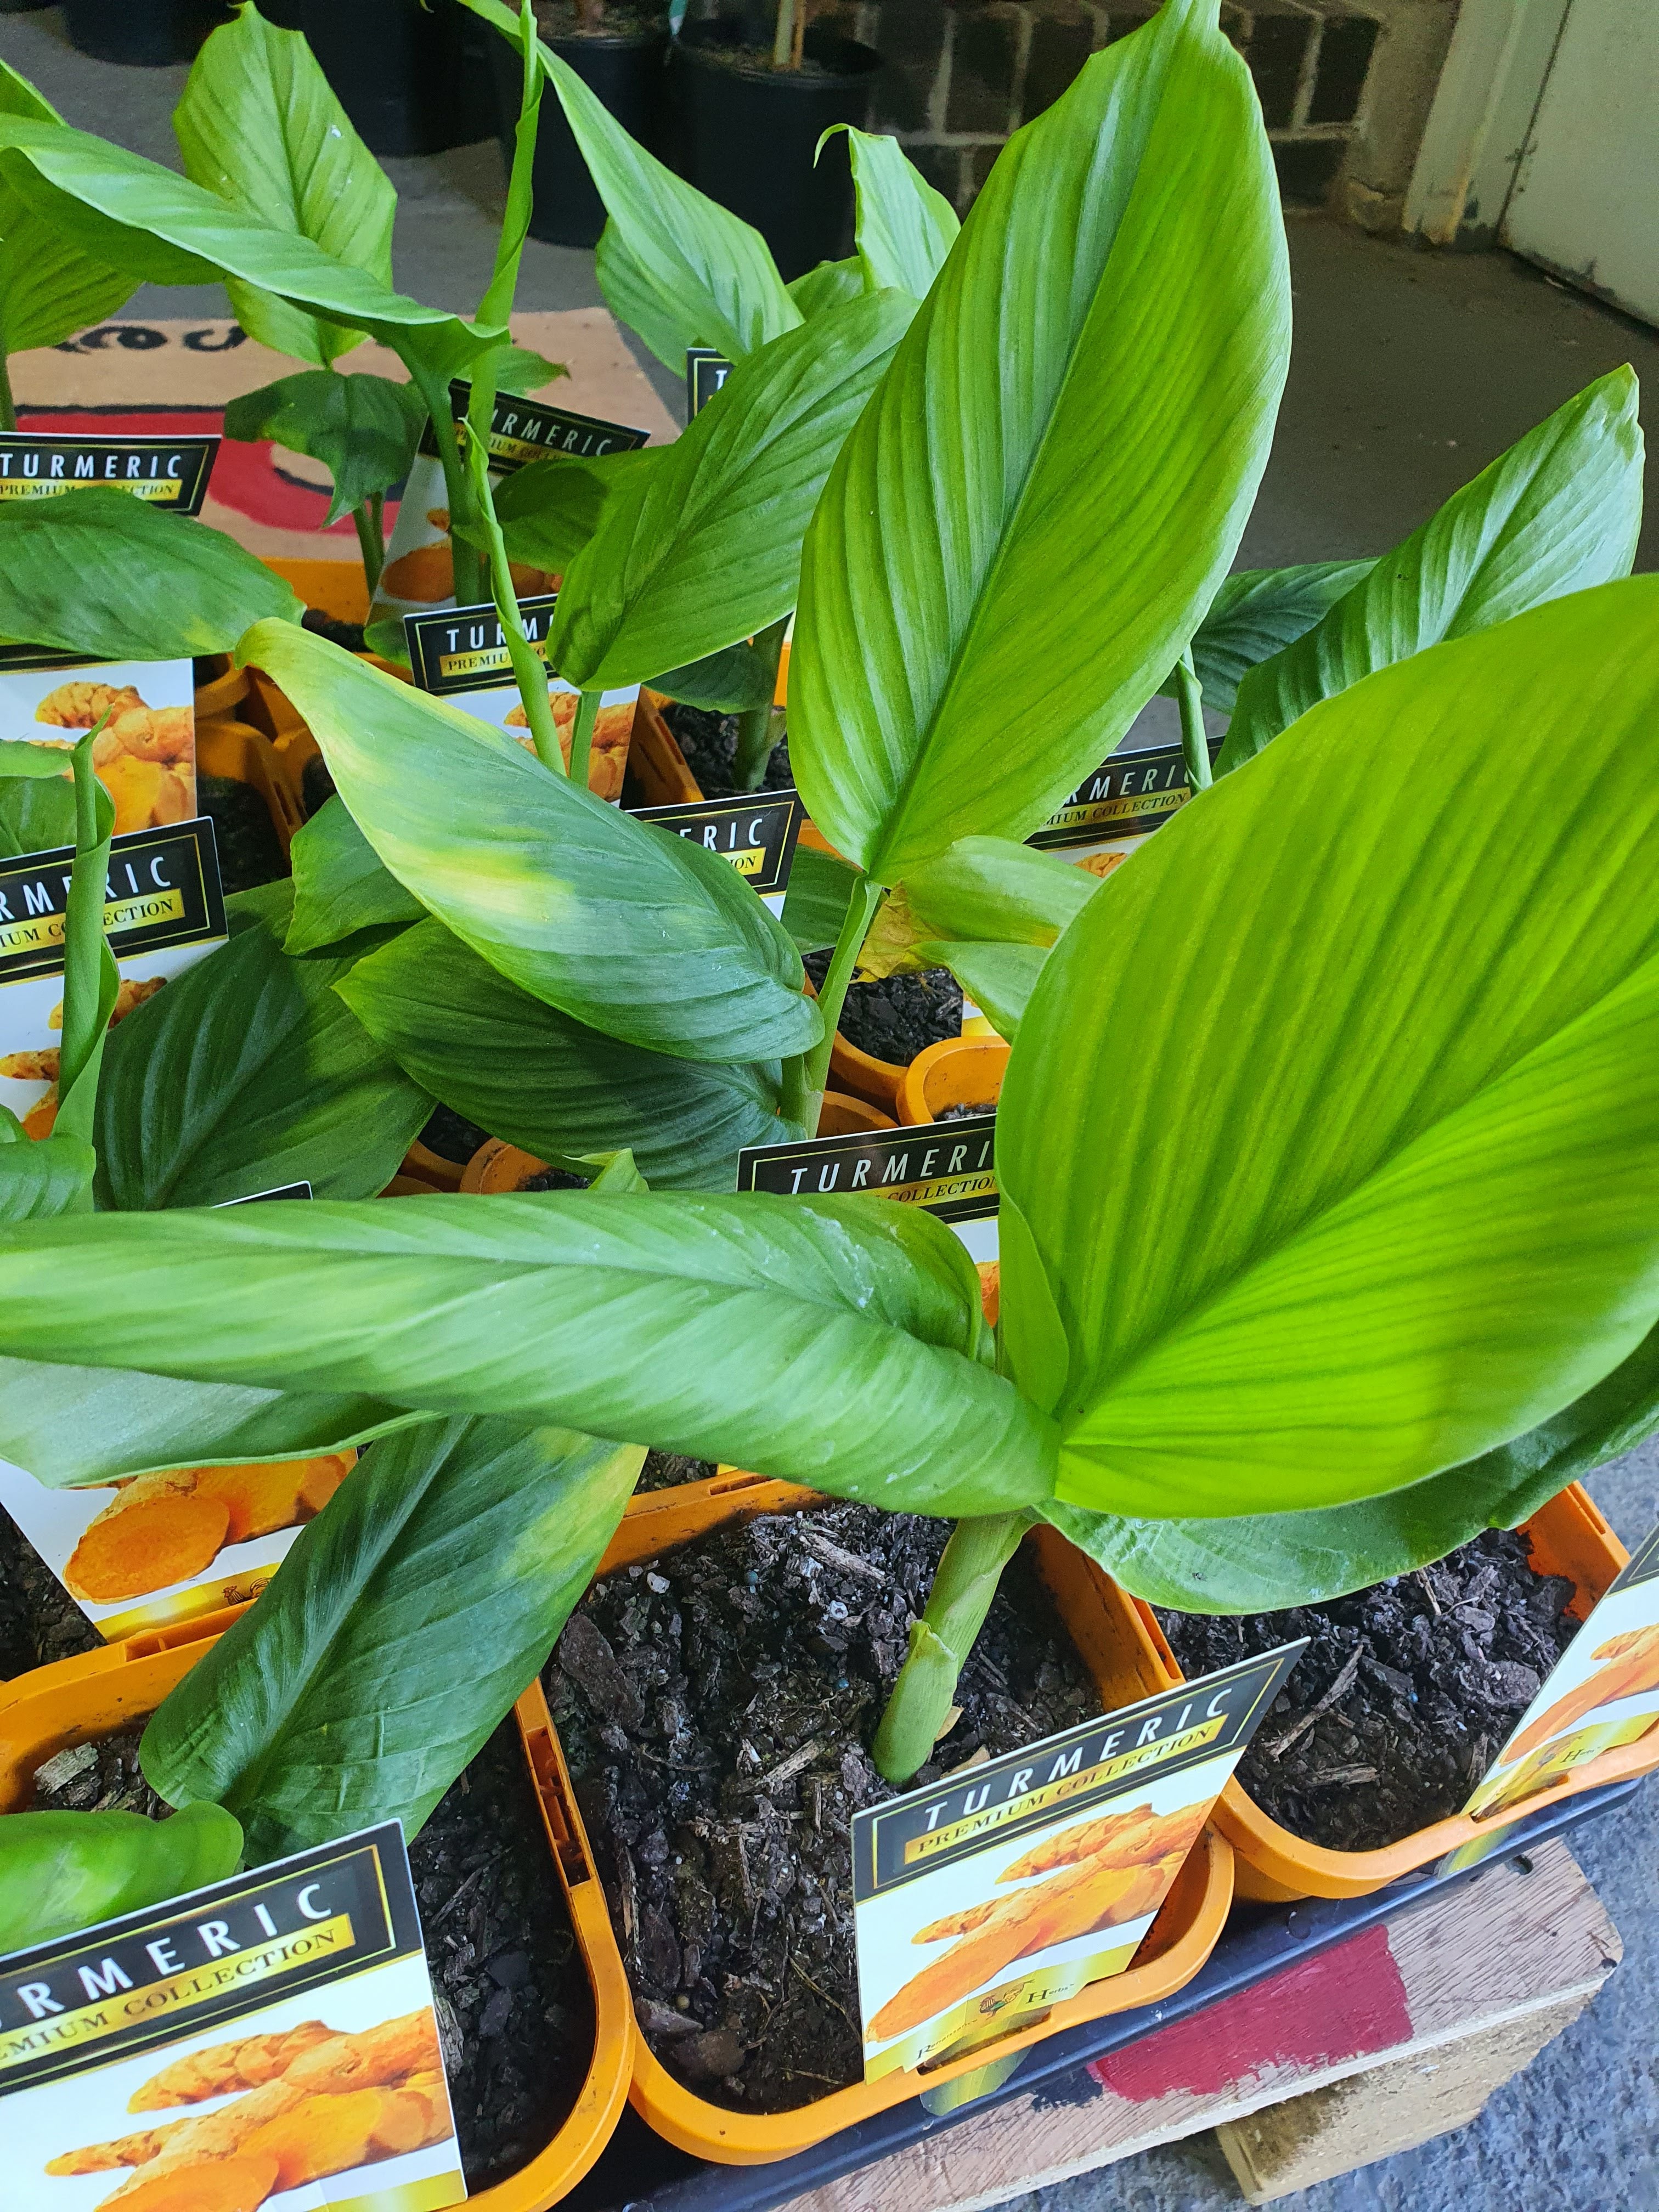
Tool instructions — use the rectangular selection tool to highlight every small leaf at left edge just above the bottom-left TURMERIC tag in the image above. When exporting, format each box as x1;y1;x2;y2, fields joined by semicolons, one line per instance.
0;1805;241;1951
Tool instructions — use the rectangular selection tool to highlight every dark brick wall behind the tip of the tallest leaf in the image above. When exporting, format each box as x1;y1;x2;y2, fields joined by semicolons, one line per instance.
812;0;1391;212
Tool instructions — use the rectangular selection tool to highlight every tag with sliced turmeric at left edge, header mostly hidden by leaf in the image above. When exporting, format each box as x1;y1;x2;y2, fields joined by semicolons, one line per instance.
0;1183;356;1644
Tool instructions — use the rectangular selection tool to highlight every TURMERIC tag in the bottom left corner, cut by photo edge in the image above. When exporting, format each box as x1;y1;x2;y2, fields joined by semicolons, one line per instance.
0;1820;467;2212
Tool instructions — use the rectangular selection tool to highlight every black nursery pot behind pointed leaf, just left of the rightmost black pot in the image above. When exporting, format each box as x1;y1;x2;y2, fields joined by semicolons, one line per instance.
489;26;668;246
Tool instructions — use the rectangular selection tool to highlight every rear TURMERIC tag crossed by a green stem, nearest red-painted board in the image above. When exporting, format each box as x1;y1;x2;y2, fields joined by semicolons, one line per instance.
369;383;650;622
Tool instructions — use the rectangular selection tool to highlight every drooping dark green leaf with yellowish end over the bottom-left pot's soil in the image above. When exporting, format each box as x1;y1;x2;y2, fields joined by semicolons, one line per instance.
139;1420;644;1865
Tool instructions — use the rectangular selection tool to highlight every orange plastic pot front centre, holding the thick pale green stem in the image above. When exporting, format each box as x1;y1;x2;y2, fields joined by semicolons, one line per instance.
566;1469;1232;2165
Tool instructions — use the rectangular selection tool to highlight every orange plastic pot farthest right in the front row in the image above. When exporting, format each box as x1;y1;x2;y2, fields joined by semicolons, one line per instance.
1110;1482;1659;1905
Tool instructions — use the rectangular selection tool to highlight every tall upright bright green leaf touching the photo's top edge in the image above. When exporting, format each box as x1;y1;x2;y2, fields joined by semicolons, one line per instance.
789;0;1290;883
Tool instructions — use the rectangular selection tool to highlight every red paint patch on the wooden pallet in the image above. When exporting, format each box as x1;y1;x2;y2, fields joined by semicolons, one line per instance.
1088;1925;1411;2103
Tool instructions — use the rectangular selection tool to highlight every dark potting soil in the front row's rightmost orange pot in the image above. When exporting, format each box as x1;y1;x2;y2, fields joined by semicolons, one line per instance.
1157;1528;1579;1852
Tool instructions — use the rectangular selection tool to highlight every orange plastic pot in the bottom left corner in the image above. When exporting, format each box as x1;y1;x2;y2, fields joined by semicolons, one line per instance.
0;1606;635;2212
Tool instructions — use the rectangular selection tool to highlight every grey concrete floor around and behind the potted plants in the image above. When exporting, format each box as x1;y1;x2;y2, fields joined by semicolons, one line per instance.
0;9;1659;2212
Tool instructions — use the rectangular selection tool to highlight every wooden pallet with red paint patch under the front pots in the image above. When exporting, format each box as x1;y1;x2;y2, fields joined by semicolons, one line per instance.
783;1841;1619;2212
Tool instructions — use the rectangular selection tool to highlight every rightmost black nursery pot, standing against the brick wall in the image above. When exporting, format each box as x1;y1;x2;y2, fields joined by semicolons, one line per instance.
675;22;881;281
